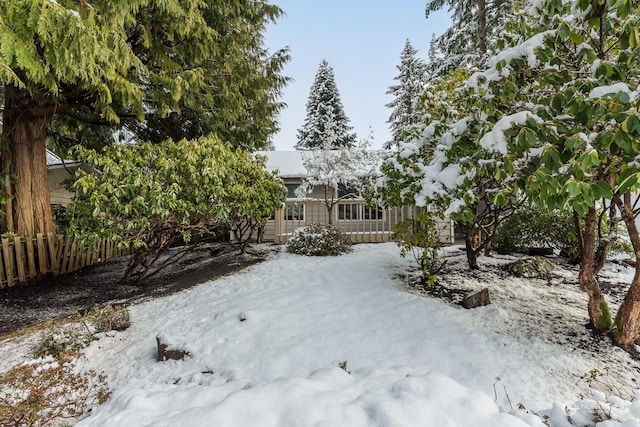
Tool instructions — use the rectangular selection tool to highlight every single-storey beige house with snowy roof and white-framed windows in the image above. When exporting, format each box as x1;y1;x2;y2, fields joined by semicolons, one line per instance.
257;151;454;244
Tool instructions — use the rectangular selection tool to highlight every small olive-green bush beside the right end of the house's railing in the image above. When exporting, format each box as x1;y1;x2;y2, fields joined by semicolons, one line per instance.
391;210;444;285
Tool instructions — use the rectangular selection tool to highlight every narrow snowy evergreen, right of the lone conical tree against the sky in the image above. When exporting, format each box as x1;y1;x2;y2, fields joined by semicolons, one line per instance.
385;39;427;149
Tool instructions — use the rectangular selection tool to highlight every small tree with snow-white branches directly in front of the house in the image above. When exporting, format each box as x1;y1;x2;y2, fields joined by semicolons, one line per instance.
296;112;381;224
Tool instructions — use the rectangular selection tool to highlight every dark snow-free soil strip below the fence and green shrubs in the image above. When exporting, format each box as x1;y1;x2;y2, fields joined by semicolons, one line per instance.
0;243;279;336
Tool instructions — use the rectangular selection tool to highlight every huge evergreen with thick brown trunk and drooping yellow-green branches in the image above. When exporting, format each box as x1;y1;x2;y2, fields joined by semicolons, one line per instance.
0;0;286;236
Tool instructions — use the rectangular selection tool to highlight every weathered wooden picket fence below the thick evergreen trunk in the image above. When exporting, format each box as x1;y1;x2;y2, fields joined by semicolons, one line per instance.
0;233;129;288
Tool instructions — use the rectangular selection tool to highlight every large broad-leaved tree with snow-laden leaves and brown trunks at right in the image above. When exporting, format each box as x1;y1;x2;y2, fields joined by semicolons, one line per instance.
386;0;640;348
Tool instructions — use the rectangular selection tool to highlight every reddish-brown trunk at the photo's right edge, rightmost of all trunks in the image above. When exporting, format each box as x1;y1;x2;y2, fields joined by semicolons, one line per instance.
614;193;640;348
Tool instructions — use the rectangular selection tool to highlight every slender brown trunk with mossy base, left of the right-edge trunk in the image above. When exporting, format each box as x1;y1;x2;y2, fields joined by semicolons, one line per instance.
578;208;611;331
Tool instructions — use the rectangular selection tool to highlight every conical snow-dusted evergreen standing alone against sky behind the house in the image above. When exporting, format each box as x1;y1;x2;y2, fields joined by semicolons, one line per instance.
296;59;356;150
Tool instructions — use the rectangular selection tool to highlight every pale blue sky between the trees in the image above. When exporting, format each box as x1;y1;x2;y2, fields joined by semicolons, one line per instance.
266;0;451;150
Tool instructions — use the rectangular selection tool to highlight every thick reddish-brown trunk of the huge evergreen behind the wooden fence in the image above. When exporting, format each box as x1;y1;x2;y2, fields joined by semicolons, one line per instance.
1;85;54;236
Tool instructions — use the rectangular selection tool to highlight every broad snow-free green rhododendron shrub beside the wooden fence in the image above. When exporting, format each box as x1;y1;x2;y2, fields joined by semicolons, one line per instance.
68;136;286;282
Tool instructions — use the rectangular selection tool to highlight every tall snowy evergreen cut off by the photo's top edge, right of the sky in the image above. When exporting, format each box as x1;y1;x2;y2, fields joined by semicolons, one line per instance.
425;0;512;76
